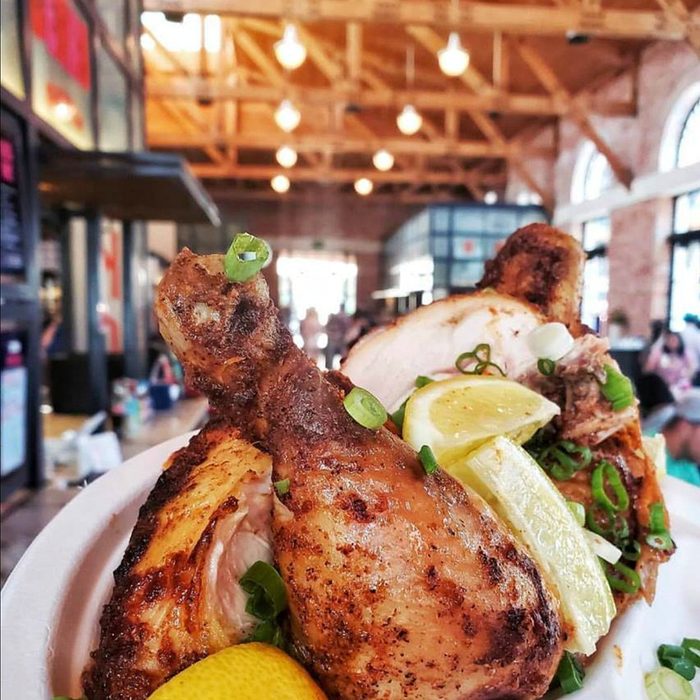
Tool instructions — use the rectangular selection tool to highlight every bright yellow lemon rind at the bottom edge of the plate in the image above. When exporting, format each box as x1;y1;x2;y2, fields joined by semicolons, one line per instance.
149;642;326;700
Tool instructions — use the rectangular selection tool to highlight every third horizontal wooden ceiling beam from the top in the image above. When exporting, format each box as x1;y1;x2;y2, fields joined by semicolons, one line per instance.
148;130;555;158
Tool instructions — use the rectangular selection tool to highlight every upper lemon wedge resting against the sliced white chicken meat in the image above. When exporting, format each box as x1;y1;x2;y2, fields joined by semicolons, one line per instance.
403;376;559;466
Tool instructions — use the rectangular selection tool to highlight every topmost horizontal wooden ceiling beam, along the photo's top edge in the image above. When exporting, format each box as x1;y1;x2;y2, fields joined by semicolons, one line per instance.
143;0;691;41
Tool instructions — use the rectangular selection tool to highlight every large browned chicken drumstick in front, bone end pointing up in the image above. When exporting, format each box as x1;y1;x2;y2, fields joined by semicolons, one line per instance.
156;250;563;700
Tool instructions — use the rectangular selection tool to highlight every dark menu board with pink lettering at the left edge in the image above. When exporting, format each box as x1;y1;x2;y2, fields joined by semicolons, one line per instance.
0;131;24;275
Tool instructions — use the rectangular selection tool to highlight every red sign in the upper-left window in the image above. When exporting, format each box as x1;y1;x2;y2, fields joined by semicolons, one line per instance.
30;0;90;90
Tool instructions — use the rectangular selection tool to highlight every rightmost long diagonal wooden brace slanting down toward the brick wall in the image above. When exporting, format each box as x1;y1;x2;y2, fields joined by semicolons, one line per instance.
515;38;632;189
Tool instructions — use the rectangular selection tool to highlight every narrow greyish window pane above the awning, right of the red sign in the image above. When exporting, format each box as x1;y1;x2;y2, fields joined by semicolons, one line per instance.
97;47;131;151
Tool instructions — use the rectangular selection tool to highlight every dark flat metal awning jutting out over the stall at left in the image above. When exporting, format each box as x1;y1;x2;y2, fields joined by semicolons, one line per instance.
39;147;221;226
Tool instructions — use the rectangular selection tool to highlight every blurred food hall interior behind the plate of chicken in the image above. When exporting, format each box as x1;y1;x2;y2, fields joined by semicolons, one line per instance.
0;0;700;581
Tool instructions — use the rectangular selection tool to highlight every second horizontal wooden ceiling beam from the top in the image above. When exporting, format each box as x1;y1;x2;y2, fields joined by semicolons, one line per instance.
146;77;634;116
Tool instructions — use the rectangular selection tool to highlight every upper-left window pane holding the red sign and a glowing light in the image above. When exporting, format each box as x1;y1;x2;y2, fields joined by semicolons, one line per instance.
30;0;93;148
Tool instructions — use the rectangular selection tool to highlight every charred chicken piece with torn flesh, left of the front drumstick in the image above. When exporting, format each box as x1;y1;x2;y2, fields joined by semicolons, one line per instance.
83;422;272;700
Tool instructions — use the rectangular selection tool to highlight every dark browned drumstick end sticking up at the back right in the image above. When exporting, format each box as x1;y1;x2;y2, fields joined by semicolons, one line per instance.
477;224;585;330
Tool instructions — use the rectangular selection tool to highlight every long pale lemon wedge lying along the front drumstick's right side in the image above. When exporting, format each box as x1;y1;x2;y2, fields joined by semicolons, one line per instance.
447;437;615;655
